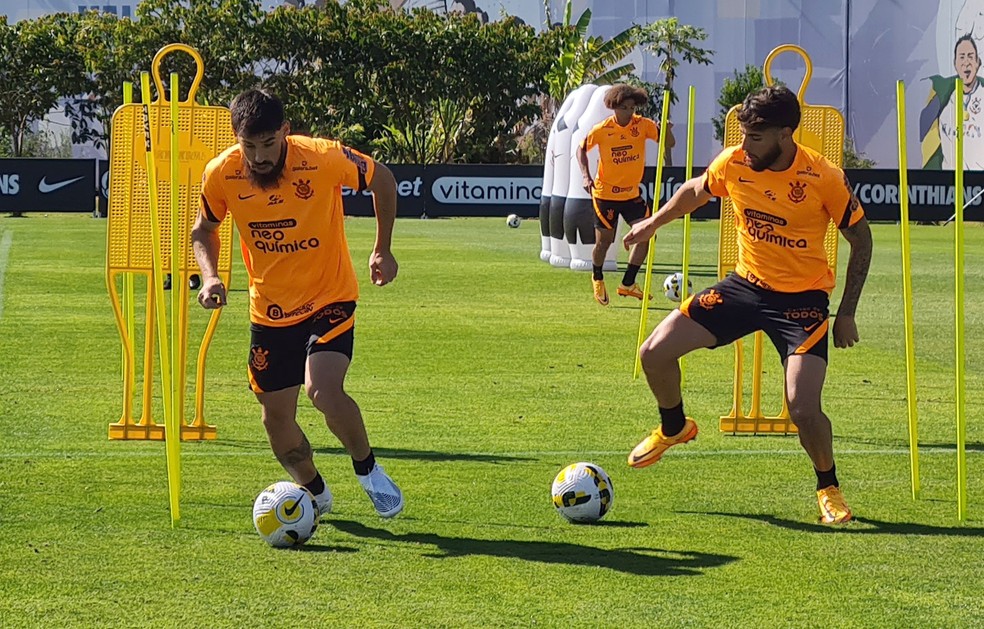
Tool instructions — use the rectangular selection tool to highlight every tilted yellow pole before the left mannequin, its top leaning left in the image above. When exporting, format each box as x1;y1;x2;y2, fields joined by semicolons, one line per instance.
140;72;181;527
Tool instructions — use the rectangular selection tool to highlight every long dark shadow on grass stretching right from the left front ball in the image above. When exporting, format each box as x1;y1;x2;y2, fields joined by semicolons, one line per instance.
331;520;738;577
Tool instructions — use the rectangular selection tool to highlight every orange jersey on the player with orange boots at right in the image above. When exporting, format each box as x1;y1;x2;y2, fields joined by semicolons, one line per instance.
703;144;864;293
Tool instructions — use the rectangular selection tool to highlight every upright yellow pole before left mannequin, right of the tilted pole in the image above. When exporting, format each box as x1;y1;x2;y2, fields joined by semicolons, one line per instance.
164;72;185;504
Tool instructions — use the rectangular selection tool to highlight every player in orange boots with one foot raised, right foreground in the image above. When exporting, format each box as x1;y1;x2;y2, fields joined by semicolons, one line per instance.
623;87;871;524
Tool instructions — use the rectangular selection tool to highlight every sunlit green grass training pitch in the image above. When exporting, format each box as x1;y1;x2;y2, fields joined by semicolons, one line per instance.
0;215;984;628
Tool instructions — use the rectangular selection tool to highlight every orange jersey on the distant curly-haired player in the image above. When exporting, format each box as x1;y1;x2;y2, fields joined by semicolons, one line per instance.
583;114;659;201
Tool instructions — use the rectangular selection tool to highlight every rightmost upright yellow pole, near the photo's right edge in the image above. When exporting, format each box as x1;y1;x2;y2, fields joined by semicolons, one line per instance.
953;77;967;522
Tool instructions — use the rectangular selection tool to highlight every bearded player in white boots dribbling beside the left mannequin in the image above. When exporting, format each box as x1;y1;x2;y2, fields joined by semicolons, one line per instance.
191;90;403;518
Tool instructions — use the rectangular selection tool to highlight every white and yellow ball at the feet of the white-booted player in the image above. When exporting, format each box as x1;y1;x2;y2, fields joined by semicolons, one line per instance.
253;481;321;548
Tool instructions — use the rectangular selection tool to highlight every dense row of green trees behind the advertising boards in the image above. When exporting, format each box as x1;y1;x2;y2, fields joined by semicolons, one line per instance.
0;0;608;162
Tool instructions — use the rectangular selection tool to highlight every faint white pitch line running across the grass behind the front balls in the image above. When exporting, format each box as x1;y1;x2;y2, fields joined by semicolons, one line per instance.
0;443;982;460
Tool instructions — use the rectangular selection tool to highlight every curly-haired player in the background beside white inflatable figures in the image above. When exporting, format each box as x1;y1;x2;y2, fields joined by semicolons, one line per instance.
577;84;673;306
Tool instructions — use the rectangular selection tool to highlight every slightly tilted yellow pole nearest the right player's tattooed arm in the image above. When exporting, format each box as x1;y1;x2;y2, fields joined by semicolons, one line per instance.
895;81;920;500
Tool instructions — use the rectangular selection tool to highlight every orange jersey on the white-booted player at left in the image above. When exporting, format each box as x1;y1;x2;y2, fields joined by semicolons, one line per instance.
201;135;375;326
